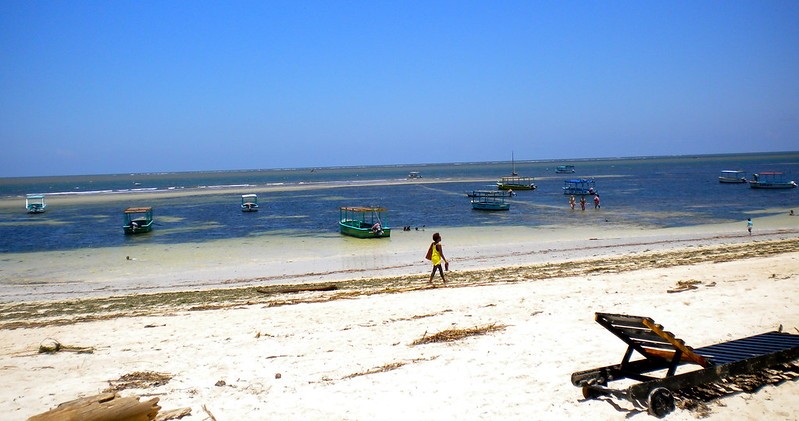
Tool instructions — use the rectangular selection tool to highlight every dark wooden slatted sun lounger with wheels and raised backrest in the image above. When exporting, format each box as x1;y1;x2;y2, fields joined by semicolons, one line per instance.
571;313;799;417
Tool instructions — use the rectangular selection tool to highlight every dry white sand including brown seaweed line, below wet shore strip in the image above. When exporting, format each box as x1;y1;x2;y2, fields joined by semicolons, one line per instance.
0;232;799;421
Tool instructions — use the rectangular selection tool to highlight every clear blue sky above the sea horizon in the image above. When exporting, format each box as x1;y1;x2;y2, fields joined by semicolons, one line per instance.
0;0;799;177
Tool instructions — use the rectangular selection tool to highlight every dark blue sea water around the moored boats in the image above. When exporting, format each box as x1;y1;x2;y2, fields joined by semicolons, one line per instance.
0;152;799;253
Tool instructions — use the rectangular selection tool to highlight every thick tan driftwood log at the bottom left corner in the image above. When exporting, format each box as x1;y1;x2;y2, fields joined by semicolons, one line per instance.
28;393;161;421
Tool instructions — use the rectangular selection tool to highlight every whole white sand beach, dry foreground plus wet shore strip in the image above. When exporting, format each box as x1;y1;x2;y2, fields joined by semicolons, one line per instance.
0;216;799;421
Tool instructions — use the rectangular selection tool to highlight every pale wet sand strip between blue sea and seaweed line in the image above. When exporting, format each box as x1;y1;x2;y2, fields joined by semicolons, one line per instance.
0;212;799;303
